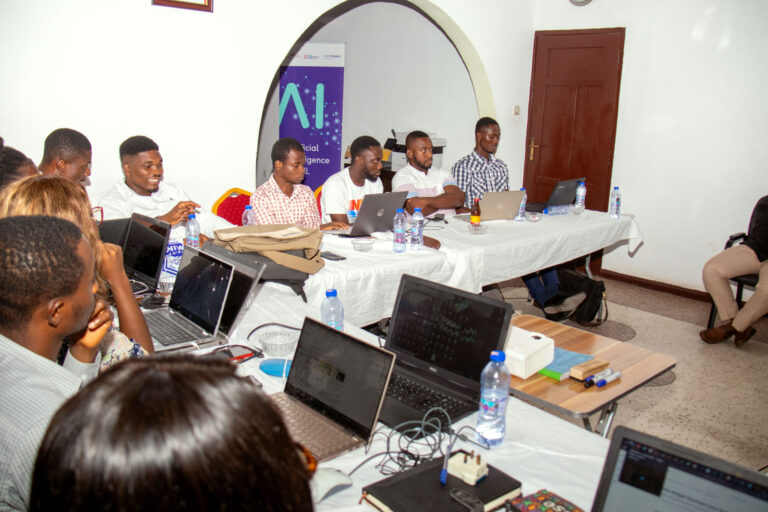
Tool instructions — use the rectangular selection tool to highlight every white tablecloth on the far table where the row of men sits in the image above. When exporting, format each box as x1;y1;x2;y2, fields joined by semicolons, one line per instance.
292;211;642;326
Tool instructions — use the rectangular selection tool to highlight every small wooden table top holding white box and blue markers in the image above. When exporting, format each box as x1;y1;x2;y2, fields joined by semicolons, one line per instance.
510;315;677;418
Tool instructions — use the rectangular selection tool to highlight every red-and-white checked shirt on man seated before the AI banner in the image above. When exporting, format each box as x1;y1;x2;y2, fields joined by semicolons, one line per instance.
251;175;320;228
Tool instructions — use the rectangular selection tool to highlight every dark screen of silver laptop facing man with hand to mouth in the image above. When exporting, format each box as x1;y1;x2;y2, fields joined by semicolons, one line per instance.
169;247;233;334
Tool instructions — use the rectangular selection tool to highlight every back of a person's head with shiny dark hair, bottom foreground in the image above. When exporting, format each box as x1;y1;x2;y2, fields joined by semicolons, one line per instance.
30;355;312;512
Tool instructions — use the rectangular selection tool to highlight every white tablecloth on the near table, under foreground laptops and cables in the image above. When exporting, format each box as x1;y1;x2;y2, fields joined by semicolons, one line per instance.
233;287;608;511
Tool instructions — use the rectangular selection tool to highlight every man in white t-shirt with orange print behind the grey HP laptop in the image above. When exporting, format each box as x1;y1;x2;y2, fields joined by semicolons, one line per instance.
320;135;384;222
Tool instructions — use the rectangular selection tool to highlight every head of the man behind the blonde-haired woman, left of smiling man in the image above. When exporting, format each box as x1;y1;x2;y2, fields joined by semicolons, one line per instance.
38;128;91;188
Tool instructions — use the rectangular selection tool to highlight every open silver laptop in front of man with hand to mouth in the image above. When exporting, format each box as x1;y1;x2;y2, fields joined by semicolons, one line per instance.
144;246;234;352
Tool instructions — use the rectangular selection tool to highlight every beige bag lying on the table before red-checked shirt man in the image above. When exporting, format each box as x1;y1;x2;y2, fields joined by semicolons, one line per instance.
213;224;325;274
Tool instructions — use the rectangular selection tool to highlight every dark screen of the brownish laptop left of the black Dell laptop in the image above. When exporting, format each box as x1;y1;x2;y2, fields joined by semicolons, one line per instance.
285;318;395;439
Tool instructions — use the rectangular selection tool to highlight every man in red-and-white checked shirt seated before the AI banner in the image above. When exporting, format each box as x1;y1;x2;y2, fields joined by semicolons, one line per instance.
251;137;347;230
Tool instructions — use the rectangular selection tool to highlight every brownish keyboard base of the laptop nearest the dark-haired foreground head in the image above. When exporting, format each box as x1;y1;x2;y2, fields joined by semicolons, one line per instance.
270;393;360;460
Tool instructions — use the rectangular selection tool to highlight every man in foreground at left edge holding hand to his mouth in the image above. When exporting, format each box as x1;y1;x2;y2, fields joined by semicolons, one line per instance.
0;216;112;510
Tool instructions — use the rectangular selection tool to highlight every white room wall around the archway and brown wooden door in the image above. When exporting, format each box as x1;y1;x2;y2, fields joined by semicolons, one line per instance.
0;0;768;289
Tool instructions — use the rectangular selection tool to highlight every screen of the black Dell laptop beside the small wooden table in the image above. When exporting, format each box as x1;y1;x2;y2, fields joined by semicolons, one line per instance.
387;275;513;389
